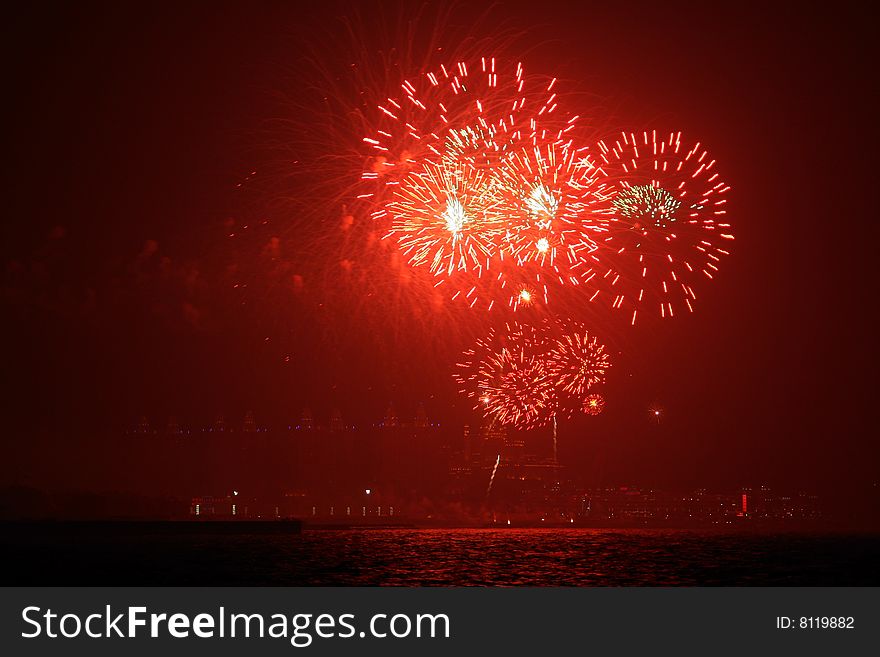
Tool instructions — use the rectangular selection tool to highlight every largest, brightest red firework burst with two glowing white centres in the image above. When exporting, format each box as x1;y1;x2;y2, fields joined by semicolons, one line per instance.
359;57;624;310
